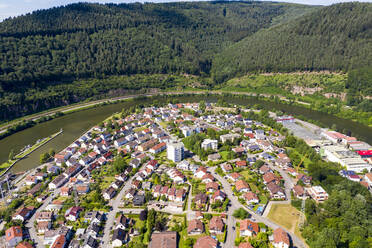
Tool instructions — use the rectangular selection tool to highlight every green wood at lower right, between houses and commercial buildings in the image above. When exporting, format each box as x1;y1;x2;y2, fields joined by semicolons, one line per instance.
285;136;372;248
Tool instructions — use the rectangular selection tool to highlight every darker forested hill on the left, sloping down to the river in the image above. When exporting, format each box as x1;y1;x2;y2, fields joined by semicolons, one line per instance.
0;2;314;120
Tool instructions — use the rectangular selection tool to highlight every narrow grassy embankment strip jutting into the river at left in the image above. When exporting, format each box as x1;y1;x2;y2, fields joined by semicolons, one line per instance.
0;129;63;177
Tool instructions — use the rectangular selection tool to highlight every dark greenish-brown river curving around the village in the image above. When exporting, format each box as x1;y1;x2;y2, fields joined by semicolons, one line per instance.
0;95;372;172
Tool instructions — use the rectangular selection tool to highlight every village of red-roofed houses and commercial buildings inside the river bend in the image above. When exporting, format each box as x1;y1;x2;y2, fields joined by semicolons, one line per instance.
1;102;372;248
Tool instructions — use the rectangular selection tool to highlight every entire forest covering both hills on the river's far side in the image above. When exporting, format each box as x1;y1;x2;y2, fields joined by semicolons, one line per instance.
0;1;372;121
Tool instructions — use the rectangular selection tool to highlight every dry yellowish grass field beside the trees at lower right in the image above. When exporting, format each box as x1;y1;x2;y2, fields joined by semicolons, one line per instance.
267;204;303;243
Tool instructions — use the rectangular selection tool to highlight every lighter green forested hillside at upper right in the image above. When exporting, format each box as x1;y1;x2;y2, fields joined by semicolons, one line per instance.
212;3;372;82
